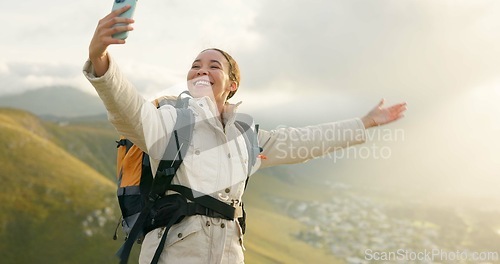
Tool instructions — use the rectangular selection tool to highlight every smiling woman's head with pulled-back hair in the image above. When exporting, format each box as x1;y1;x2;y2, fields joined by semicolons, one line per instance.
187;50;236;104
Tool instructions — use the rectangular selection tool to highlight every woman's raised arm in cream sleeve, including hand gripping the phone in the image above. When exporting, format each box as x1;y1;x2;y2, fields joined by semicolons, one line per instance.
83;7;177;172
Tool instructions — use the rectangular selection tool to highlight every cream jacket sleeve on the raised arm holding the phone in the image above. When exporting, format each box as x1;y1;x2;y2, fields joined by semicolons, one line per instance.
83;55;177;169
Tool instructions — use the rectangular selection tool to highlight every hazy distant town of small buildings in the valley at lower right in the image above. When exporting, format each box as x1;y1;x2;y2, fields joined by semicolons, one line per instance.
270;183;500;264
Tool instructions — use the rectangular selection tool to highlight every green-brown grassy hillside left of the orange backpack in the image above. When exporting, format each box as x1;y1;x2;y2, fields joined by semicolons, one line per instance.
0;109;136;263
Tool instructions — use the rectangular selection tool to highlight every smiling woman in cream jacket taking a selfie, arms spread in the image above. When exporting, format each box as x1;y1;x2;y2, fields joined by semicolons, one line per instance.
80;2;406;264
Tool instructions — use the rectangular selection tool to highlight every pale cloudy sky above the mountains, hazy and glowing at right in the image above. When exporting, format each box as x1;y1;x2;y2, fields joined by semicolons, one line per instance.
0;0;500;201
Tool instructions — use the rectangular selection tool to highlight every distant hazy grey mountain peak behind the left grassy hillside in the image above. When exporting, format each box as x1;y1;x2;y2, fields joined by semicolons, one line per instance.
0;86;106;117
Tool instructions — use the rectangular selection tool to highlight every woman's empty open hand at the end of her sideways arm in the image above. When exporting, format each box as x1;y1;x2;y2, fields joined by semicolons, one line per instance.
361;99;407;128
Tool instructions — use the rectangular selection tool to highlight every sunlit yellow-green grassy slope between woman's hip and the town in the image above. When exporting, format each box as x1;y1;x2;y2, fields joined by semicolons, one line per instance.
243;170;343;264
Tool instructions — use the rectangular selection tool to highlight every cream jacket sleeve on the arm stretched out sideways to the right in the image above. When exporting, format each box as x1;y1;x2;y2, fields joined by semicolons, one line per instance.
259;118;366;168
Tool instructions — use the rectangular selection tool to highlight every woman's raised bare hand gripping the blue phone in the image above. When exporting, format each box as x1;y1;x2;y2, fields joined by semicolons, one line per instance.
89;5;134;76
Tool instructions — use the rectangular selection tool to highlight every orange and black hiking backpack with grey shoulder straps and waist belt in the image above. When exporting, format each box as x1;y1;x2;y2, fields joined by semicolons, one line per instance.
113;92;262;263
